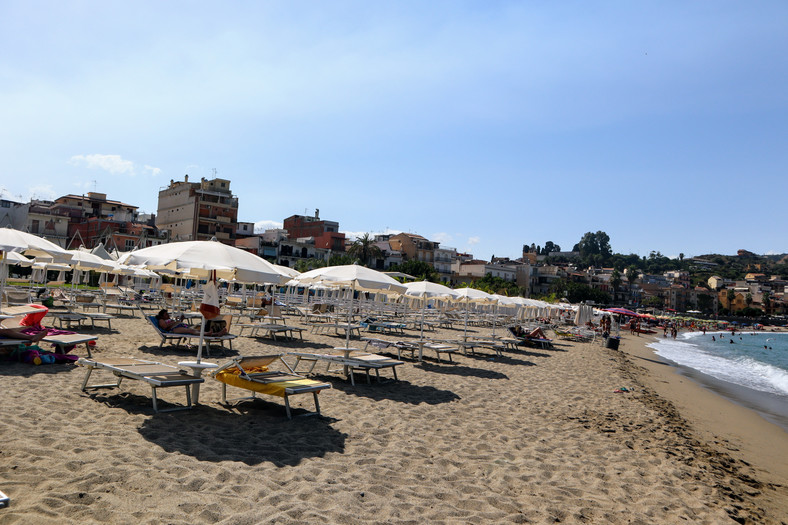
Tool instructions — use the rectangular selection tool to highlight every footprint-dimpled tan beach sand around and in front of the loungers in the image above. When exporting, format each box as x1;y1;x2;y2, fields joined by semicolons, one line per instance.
0;317;788;524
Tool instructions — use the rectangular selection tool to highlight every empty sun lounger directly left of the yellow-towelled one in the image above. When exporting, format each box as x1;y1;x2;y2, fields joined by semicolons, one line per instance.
77;357;205;412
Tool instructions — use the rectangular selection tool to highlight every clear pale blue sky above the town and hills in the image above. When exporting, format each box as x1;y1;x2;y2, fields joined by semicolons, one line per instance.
0;0;788;260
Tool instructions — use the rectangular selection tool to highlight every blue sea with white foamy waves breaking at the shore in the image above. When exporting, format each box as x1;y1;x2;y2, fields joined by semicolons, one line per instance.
648;331;788;432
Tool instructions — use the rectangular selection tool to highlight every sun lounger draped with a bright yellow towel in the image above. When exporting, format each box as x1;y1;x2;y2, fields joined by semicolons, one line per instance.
211;354;331;419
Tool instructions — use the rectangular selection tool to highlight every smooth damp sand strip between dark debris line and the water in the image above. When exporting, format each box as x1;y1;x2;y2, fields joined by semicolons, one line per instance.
619;335;788;496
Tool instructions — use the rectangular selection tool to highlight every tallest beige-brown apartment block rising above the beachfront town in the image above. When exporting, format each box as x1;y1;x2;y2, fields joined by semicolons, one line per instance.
156;175;238;245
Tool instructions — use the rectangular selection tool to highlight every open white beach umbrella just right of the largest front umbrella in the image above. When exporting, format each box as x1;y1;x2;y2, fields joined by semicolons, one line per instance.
293;264;407;348
